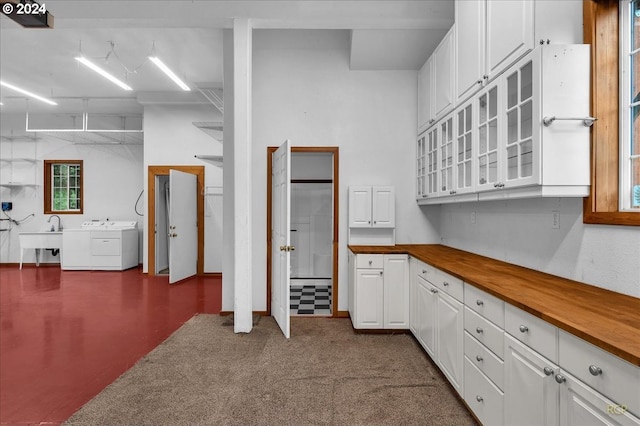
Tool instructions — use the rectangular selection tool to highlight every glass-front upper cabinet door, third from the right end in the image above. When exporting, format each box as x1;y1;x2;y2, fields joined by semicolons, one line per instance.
454;102;475;194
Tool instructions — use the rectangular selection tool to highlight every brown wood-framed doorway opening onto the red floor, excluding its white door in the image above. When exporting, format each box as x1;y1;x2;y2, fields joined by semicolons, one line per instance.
147;166;204;276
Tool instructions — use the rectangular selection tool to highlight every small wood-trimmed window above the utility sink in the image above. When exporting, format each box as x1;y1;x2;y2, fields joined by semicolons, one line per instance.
44;160;83;214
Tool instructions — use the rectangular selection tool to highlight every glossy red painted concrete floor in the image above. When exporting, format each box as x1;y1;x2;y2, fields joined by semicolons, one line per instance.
0;265;222;425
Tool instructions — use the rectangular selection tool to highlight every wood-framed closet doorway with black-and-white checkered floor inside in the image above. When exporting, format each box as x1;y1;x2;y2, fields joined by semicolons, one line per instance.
267;147;339;317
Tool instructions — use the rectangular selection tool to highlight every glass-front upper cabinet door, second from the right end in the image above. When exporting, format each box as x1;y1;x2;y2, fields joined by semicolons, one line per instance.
476;83;500;191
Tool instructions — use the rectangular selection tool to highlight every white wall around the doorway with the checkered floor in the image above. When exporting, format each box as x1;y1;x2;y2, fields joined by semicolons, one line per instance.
252;30;439;311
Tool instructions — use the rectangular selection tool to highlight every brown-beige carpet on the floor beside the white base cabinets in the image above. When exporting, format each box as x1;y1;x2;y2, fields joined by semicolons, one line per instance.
65;315;476;425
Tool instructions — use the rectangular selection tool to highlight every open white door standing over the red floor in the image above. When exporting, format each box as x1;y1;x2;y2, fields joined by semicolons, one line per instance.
169;170;198;284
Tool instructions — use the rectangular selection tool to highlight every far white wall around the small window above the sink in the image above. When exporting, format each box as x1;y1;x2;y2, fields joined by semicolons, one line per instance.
0;114;144;263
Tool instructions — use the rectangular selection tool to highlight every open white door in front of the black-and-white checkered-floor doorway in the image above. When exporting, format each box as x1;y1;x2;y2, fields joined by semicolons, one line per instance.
271;139;295;339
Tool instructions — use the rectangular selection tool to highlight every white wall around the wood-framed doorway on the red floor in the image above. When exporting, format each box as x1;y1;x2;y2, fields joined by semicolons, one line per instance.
141;104;222;272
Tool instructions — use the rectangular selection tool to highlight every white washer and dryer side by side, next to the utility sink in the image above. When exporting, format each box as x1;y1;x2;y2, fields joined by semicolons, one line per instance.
61;220;138;271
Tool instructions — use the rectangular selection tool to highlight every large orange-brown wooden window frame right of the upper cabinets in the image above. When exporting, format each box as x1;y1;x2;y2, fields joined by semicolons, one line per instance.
583;0;640;226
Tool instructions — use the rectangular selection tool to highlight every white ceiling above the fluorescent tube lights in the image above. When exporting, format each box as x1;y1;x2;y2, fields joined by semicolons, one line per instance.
0;0;454;113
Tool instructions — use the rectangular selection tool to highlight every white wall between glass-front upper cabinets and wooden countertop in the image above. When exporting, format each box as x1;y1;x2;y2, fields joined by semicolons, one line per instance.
441;198;640;297
